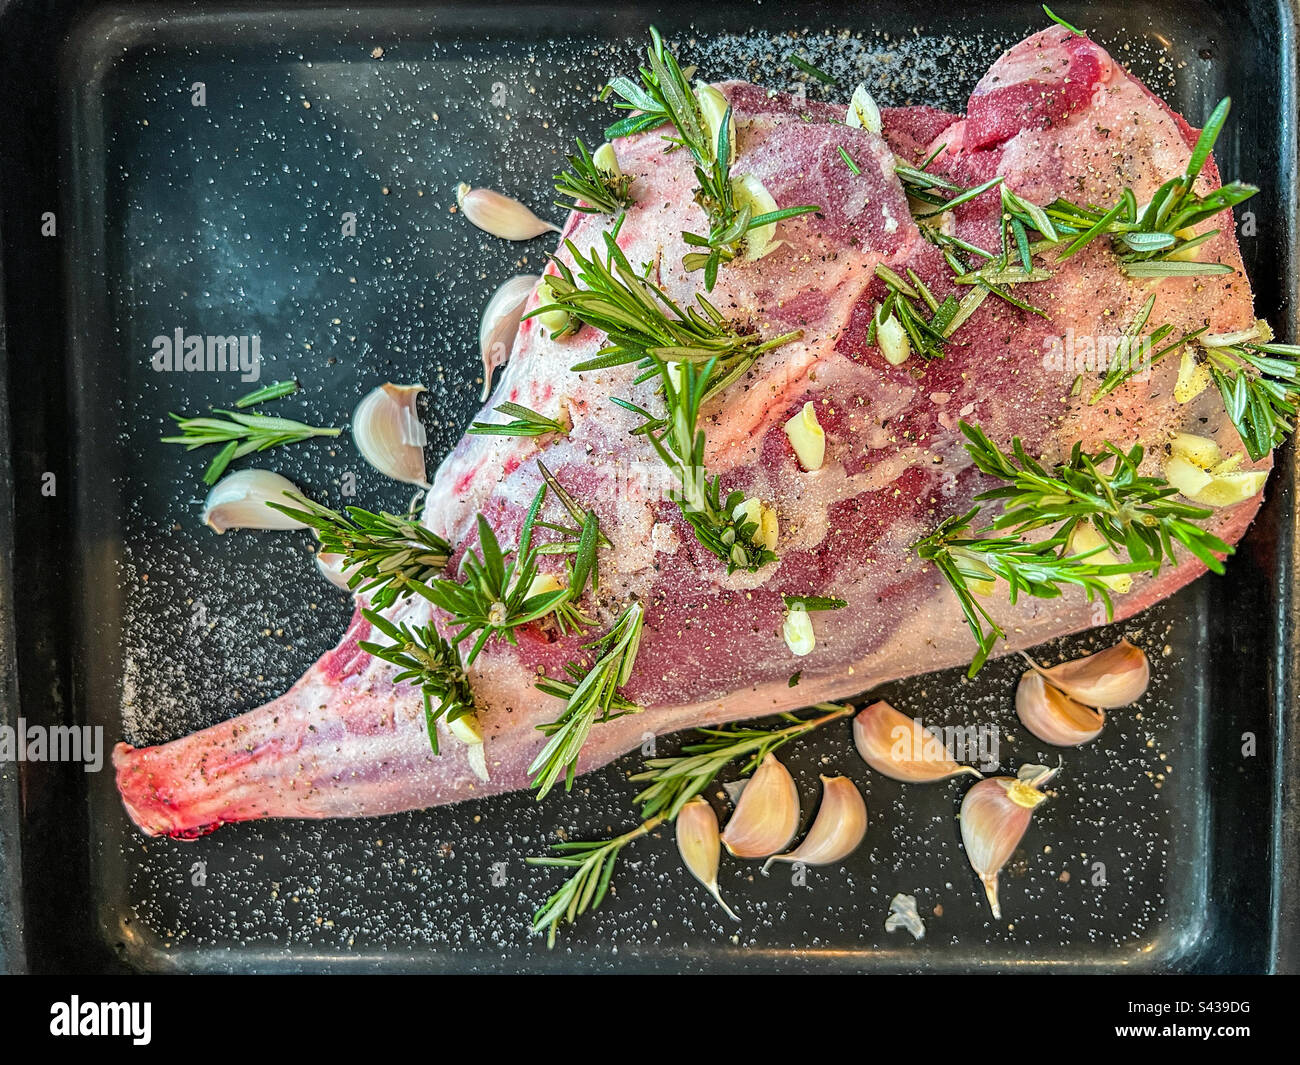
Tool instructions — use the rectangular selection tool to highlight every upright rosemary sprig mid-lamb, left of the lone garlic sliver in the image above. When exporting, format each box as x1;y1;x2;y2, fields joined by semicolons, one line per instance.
614;359;776;573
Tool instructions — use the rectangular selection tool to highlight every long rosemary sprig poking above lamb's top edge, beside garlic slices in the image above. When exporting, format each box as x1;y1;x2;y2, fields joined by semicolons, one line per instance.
601;26;822;291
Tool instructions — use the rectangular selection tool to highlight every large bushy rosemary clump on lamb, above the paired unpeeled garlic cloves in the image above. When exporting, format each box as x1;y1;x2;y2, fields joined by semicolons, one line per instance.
913;421;1232;676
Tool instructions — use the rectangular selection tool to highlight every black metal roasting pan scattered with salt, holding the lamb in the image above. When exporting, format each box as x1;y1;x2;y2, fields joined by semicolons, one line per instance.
0;0;1300;973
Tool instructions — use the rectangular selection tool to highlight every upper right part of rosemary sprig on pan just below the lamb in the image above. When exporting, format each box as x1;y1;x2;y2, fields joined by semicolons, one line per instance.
629;702;853;821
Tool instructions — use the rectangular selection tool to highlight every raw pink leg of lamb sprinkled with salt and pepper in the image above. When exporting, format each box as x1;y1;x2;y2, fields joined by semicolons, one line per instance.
114;29;1269;836
